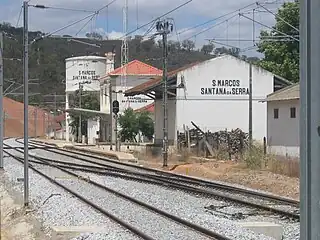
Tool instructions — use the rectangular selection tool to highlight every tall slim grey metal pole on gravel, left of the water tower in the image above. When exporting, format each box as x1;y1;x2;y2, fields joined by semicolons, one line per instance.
23;1;29;206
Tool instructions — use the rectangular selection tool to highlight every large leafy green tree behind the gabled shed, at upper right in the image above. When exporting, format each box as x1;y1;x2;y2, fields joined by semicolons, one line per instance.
258;1;299;82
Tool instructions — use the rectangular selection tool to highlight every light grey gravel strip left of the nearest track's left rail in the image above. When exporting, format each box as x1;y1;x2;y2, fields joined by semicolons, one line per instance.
4;140;139;240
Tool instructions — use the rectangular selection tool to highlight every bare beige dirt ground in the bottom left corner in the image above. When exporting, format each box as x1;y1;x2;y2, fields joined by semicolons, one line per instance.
0;171;67;240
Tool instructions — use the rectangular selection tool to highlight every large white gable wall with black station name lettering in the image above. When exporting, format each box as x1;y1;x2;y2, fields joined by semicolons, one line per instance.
176;56;274;140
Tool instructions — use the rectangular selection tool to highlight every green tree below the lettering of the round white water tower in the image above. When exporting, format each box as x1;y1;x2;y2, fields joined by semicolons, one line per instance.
70;90;100;139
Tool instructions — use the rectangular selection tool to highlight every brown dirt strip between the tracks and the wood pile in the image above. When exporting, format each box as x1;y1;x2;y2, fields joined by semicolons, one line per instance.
141;159;299;199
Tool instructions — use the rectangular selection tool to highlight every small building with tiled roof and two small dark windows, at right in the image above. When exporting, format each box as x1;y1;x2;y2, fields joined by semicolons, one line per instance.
267;83;300;157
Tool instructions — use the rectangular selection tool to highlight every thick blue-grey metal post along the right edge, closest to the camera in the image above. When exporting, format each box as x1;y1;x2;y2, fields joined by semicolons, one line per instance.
299;0;320;240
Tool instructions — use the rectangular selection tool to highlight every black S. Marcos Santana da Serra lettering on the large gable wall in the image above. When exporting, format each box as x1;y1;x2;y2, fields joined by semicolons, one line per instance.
200;79;249;95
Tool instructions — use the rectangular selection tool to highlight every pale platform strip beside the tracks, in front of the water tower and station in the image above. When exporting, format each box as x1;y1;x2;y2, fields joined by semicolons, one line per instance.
34;139;137;163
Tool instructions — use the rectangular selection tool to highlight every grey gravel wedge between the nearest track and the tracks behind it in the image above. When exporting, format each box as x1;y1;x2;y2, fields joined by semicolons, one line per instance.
5;140;299;240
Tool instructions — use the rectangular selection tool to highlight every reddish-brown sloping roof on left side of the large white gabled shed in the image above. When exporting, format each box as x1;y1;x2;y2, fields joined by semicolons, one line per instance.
125;62;200;96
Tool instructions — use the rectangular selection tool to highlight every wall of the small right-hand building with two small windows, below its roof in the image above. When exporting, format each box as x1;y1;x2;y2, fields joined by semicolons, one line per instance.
267;99;300;157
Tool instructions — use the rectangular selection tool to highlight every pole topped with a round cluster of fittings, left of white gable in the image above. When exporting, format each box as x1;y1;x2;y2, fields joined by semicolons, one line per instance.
156;20;173;167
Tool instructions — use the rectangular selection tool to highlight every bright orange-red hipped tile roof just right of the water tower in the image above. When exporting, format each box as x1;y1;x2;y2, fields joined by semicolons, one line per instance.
108;60;162;76
